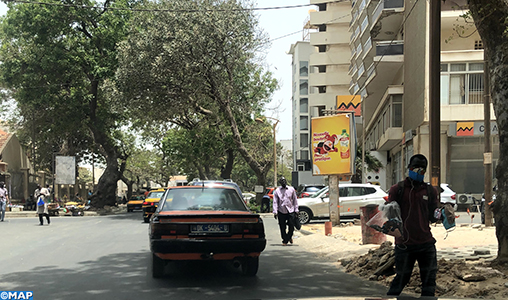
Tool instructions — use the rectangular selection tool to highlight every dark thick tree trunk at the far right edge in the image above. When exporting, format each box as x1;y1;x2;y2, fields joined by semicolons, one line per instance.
468;0;508;262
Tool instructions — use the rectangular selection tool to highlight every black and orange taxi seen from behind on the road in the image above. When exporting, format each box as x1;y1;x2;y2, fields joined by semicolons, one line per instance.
149;185;266;278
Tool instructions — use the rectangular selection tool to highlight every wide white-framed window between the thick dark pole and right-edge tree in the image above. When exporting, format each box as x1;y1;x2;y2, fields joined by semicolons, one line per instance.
441;63;484;105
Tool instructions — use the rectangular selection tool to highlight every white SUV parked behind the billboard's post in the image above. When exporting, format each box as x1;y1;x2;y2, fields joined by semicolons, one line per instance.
298;183;388;224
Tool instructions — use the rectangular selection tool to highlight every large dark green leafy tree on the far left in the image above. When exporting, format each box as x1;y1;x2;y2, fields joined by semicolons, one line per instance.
0;0;133;207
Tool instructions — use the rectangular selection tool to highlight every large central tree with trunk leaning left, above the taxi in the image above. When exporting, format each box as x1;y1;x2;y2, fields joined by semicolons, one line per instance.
117;0;277;204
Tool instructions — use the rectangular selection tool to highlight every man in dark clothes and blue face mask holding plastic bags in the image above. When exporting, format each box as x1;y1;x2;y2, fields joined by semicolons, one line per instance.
387;154;439;297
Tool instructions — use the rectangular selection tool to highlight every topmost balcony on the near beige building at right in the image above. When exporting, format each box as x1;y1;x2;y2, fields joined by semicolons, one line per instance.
370;0;404;40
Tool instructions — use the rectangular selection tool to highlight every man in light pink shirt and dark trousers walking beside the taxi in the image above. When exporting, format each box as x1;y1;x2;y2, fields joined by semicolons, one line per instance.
273;177;298;246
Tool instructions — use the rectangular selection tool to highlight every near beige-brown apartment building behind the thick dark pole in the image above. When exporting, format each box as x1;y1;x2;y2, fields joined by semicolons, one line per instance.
349;0;499;199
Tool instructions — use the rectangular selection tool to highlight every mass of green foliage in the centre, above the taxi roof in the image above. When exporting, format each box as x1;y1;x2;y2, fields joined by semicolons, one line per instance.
117;0;278;188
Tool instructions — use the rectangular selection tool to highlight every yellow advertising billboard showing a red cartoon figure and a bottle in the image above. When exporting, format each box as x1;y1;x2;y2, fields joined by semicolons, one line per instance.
311;113;356;175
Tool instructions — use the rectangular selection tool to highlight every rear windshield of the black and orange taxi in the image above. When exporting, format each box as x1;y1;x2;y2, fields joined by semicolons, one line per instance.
161;188;248;211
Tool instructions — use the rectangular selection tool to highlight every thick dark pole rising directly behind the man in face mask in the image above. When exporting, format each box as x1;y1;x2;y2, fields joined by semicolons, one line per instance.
429;0;441;191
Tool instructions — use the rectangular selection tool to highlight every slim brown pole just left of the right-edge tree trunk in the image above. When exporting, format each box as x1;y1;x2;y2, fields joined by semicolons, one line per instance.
483;59;492;227
